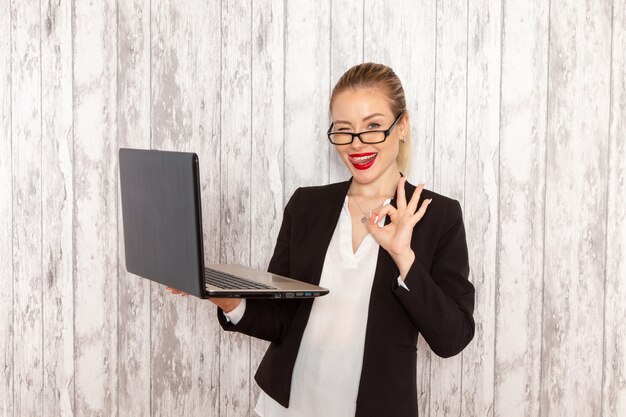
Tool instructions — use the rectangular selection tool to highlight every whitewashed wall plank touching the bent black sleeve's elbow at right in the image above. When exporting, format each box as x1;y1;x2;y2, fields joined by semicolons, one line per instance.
461;1;502;417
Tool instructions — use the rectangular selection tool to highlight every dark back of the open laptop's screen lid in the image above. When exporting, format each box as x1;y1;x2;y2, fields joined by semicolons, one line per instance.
119;148;205;298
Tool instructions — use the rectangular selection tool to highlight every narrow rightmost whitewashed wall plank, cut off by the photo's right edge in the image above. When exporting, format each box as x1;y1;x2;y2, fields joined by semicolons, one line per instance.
602;1;626;417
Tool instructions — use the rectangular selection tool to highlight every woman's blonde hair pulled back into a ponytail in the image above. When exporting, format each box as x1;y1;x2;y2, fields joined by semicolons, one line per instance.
328;62;411;176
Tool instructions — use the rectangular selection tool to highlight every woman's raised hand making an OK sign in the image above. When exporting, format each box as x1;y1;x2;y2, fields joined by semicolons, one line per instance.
367;177;432;278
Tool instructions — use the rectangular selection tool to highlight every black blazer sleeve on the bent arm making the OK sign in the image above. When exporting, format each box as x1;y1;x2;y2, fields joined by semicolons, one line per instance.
392;200;474;358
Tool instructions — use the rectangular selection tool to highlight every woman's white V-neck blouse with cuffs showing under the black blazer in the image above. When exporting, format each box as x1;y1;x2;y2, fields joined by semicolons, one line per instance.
226;196;408;417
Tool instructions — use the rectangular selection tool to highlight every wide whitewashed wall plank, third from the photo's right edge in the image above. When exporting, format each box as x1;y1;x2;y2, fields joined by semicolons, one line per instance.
494;0;548;417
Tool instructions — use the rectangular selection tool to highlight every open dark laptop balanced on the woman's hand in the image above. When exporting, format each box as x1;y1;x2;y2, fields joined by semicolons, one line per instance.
119;148;329;299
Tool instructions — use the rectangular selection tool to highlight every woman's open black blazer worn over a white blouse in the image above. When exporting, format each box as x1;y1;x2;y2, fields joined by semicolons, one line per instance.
218;180;474;417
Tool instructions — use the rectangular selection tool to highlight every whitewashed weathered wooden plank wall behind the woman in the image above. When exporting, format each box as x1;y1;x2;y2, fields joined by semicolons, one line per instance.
0;0;626;417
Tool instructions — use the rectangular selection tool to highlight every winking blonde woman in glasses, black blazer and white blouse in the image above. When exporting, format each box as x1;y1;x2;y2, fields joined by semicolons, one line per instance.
168;63;474;417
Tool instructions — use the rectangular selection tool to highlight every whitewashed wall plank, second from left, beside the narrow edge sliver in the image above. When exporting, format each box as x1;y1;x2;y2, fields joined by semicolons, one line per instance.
11;2;43;416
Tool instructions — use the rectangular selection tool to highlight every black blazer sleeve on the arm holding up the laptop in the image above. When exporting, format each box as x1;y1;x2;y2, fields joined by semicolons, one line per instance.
217;189;301;342
